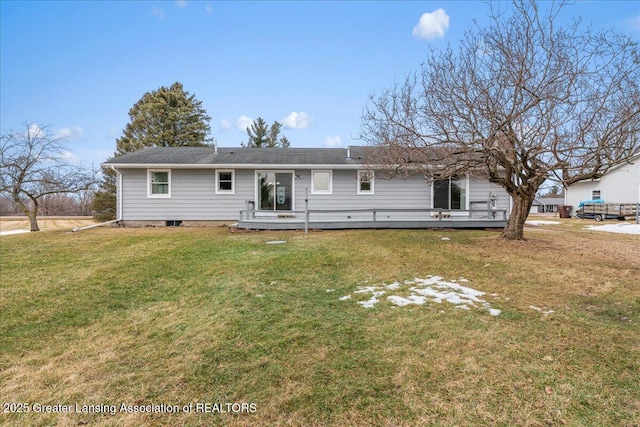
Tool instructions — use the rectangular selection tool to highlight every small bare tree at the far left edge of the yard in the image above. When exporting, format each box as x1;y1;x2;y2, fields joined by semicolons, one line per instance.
0;123;93;231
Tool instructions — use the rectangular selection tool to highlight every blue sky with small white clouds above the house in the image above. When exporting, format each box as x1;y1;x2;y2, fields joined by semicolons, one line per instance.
0;0;640;166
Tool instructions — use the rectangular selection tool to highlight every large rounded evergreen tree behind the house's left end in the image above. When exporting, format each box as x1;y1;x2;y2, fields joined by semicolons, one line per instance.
93;82;211;221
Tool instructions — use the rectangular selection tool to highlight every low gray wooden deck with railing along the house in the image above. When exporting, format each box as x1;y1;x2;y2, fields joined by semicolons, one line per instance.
234;209;507;230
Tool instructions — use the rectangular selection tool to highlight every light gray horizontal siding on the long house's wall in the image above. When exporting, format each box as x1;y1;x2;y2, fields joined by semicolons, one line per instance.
120;168;509;221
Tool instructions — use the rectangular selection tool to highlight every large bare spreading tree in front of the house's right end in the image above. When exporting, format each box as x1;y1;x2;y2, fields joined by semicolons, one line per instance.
361;0;640;240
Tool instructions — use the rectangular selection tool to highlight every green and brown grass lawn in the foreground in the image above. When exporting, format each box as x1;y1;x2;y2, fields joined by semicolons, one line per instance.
0;220;640;427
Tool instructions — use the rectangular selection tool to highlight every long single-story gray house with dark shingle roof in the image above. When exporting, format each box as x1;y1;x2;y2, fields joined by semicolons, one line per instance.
103;147;510;229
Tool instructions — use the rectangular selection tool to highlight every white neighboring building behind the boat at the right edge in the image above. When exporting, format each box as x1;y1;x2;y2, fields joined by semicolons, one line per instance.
565;155;640;212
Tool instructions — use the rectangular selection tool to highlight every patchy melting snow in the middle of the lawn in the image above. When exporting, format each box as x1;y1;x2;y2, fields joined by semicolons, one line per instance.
339;276;501;316
